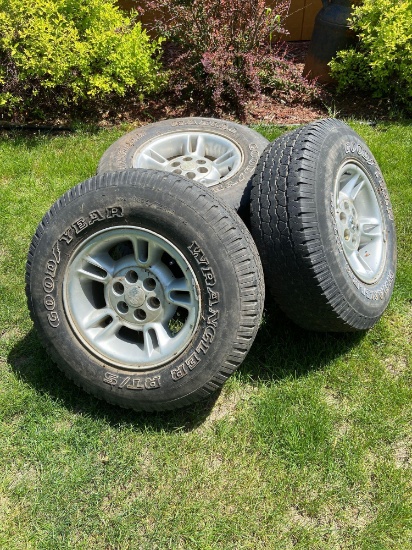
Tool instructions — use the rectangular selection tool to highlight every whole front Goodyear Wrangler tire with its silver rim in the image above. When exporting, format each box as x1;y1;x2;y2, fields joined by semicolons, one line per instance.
26;169;264;411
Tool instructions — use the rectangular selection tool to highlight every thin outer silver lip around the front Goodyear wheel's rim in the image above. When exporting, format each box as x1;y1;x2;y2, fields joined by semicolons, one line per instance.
62;225;202;372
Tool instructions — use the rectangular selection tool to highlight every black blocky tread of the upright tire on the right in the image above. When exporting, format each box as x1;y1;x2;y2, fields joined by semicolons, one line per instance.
251;119;388;332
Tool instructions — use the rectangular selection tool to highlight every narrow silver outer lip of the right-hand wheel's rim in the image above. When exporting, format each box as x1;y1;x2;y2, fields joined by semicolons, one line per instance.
333;159;387;285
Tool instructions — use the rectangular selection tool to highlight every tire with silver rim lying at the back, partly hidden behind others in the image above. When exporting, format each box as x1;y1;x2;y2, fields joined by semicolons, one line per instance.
97;117;269;218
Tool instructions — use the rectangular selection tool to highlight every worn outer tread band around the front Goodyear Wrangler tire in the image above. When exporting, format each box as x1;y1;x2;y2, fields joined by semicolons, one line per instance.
26;170;264;411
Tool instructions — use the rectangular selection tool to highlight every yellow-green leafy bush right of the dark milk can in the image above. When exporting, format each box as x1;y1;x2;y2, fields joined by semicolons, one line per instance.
330;0;412;112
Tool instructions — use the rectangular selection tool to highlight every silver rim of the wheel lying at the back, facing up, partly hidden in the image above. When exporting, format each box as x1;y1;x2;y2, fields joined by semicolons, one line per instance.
133;132;242;187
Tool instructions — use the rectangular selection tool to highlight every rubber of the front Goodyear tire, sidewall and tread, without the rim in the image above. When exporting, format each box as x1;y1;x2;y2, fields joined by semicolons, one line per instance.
26;170;264;411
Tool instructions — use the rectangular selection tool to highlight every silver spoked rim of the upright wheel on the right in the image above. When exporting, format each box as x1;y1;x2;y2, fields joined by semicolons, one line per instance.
335;162;386;284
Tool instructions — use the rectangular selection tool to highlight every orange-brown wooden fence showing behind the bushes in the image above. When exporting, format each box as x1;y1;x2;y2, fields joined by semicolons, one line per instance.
118;0;322;41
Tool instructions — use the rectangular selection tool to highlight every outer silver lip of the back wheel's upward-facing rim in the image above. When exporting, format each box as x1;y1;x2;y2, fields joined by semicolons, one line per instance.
132;128;245;188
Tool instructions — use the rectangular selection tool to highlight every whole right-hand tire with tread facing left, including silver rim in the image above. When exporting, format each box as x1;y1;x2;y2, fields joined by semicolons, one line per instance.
251;119;396;332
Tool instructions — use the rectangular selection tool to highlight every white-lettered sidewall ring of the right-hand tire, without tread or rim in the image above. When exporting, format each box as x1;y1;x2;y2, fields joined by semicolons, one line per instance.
315;125;396;317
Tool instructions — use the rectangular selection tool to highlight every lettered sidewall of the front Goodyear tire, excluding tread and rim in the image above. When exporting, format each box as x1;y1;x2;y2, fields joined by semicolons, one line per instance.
30;175;248;408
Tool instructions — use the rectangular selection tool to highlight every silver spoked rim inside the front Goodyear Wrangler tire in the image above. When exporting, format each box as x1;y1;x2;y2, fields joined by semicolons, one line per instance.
63;227;200;370
